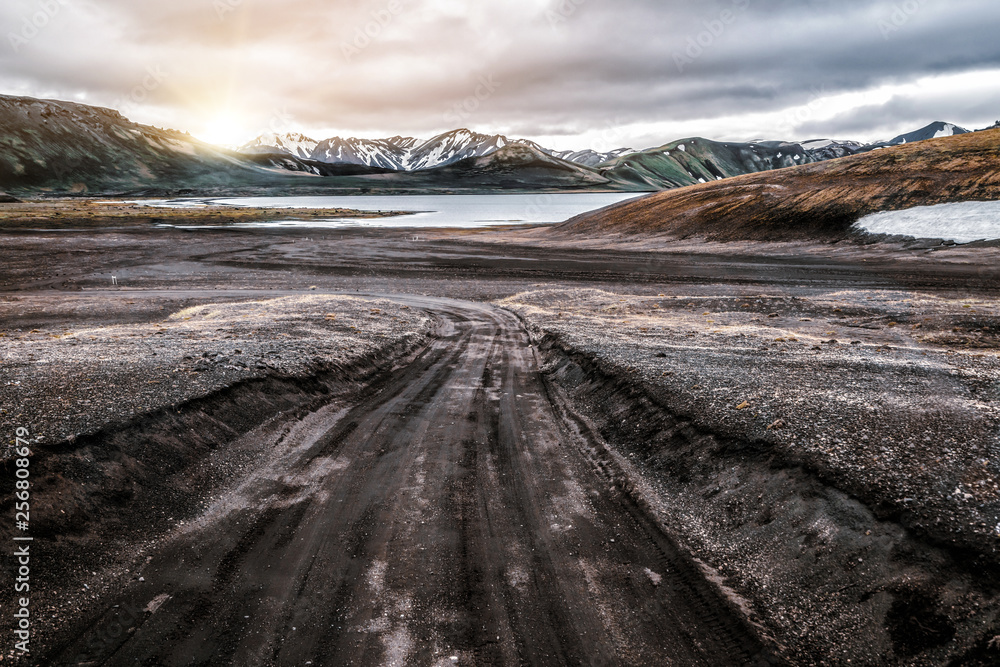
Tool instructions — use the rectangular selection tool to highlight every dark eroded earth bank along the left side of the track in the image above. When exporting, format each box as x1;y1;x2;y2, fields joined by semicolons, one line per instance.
0;341;423;660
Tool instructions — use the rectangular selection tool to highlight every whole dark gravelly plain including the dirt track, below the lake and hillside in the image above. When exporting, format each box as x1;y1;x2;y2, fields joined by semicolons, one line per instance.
0;211;1000;665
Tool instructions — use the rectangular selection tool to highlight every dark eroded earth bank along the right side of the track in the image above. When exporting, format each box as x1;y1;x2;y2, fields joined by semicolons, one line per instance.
529;325;1000;665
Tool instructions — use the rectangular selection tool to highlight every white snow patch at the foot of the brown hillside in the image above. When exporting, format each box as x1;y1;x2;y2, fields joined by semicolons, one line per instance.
856;201;1000;248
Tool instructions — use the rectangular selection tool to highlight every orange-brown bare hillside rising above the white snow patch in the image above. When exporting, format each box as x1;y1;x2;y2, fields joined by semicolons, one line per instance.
549;130;1000;241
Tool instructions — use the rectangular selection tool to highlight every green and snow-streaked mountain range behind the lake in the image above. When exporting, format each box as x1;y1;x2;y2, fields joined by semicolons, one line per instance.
0;96;984;196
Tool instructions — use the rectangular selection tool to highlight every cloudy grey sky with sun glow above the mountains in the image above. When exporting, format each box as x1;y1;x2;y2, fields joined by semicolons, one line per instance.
0;0;1000;149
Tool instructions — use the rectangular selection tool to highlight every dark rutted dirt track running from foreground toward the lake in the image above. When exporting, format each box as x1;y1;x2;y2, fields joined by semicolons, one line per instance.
54;298;772;666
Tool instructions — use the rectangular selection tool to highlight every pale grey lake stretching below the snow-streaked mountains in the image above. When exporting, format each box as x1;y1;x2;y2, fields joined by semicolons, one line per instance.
141;192;643;228
